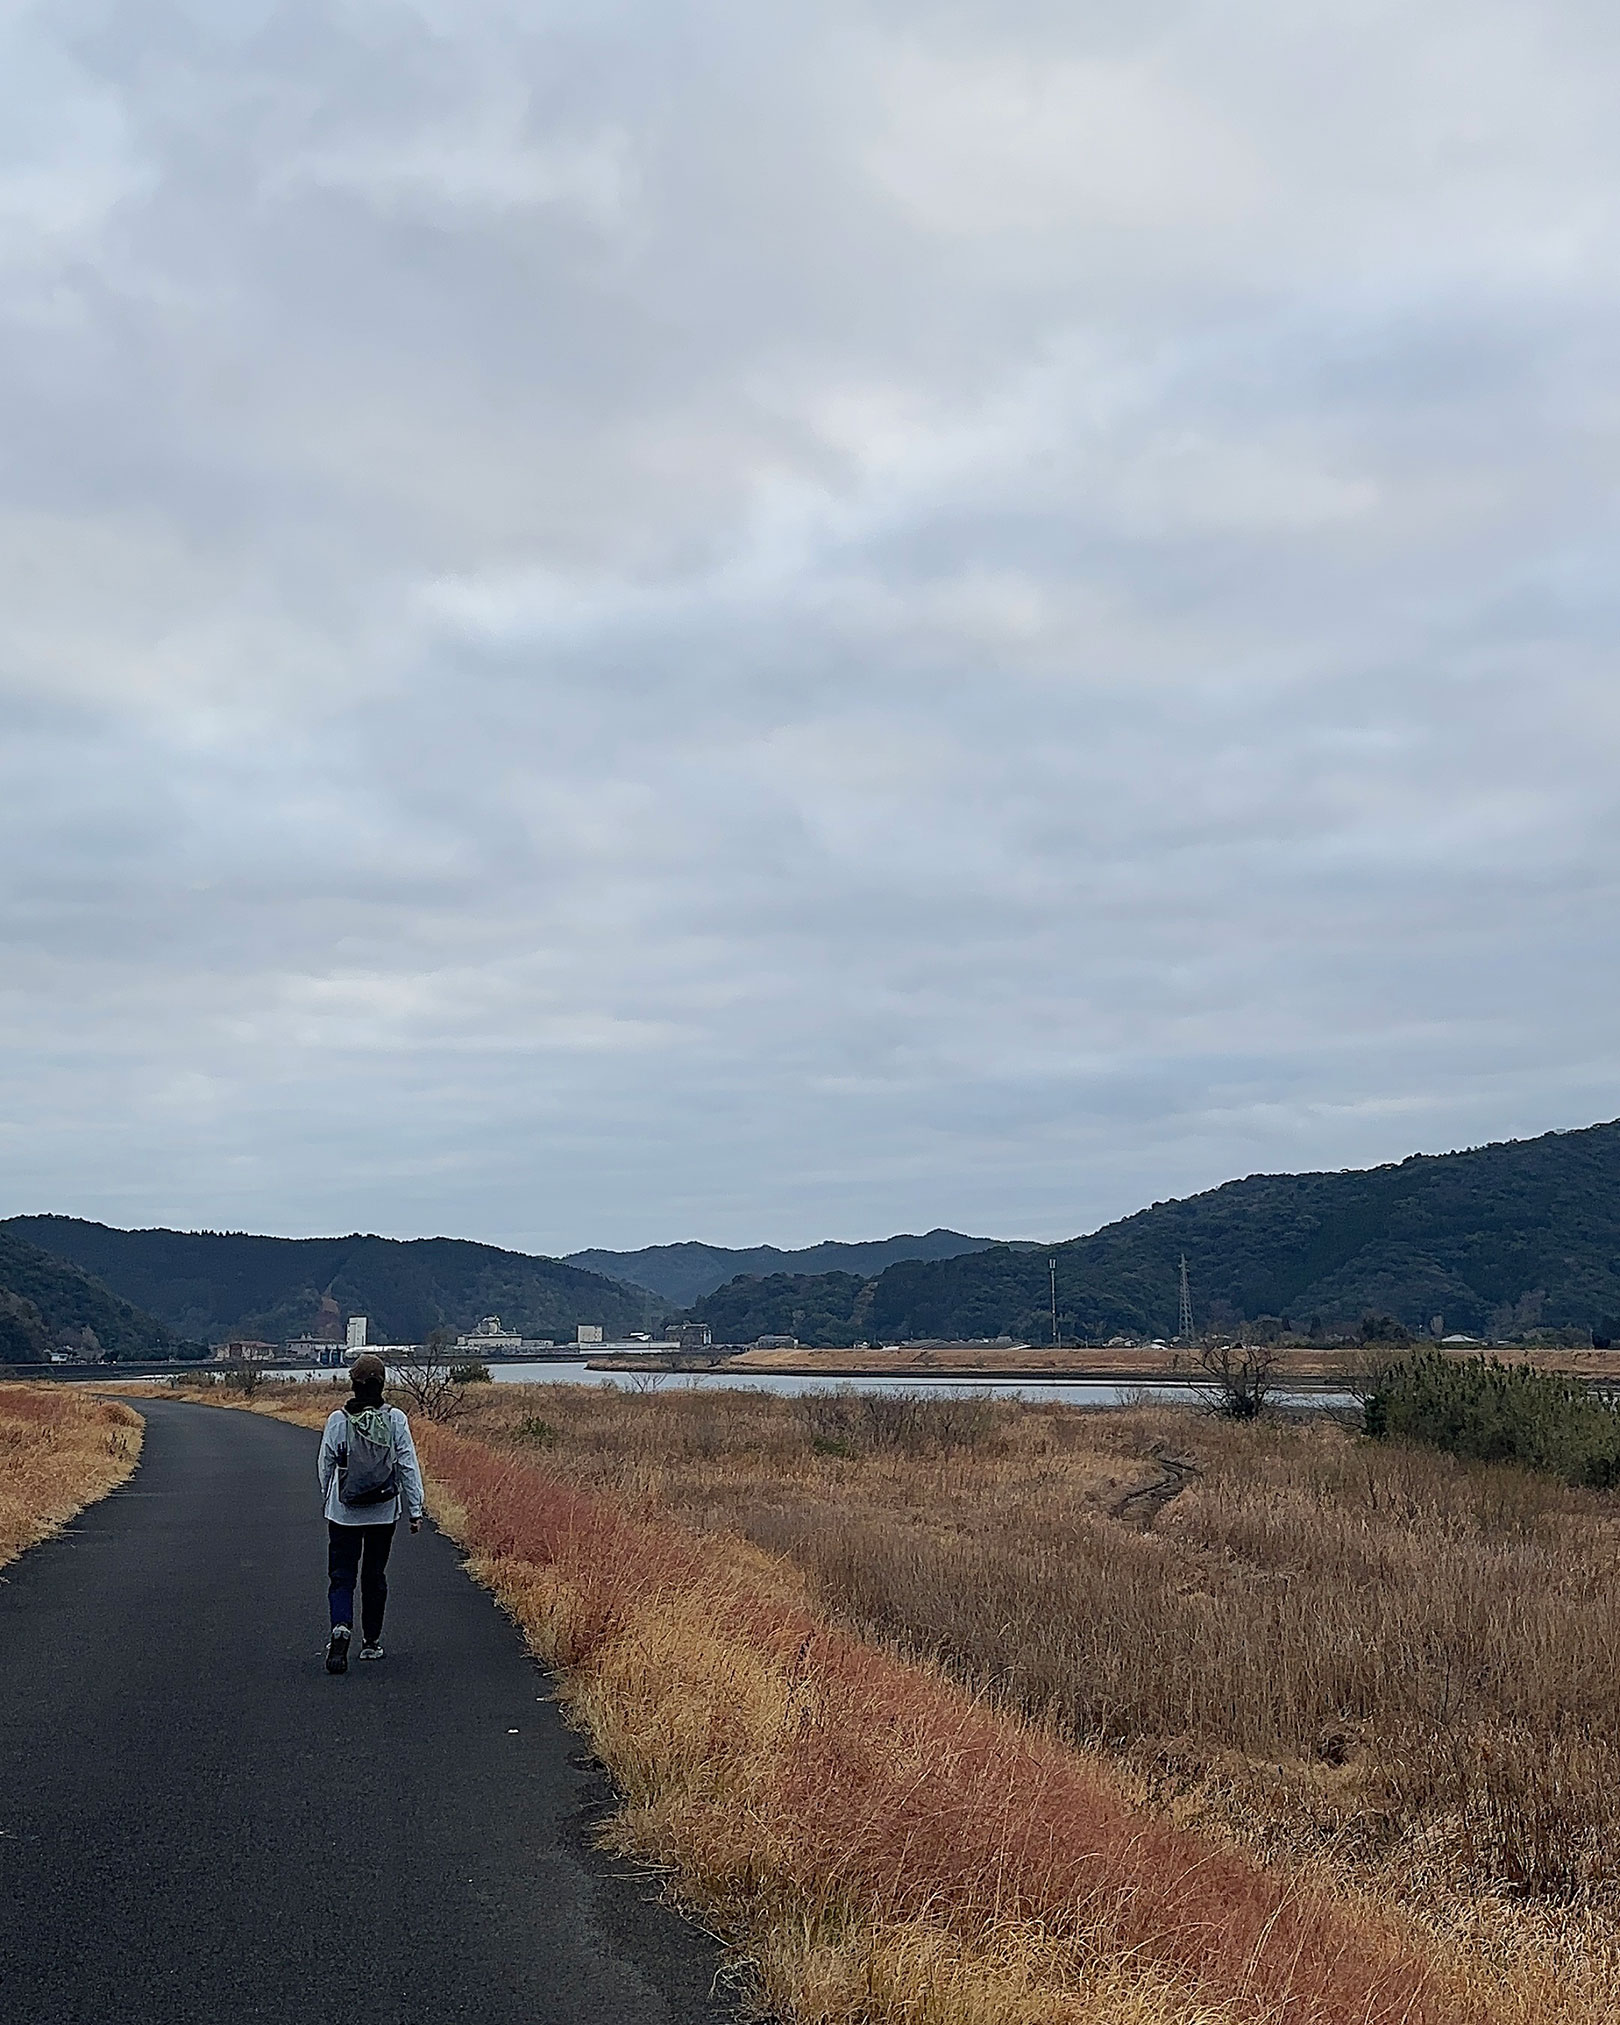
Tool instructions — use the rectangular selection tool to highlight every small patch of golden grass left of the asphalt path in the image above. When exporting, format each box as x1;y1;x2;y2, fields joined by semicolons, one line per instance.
0;1381;142;1567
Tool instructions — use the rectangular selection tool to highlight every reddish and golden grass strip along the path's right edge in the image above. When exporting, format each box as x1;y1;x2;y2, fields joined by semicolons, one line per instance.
425;1430;1488;2025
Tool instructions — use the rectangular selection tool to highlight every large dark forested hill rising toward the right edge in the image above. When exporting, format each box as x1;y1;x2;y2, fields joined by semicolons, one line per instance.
695;1124;1620;1343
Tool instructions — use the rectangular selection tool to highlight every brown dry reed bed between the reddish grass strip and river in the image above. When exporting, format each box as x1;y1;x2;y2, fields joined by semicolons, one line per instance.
455;1387;1620;1895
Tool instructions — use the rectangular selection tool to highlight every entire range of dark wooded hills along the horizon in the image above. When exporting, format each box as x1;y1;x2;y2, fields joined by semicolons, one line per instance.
15;1122;1620;1355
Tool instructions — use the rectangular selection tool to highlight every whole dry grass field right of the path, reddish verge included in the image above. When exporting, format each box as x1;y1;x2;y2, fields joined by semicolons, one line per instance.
168;1381;1620;2025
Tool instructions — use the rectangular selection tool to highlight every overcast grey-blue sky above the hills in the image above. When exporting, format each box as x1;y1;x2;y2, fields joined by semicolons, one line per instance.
0;0;1620;1251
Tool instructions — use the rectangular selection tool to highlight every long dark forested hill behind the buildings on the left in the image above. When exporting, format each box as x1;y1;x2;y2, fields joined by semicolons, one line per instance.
0;1217;660;1343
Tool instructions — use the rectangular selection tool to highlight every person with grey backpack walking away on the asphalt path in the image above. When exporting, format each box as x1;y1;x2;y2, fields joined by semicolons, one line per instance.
318;1351;423;1673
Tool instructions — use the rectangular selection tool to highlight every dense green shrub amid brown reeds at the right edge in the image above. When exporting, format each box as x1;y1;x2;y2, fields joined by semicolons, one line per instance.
1363;1351;1620;1490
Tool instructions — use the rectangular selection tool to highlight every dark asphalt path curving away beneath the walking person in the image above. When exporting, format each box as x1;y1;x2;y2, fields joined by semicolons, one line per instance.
0;1401;735;2025
